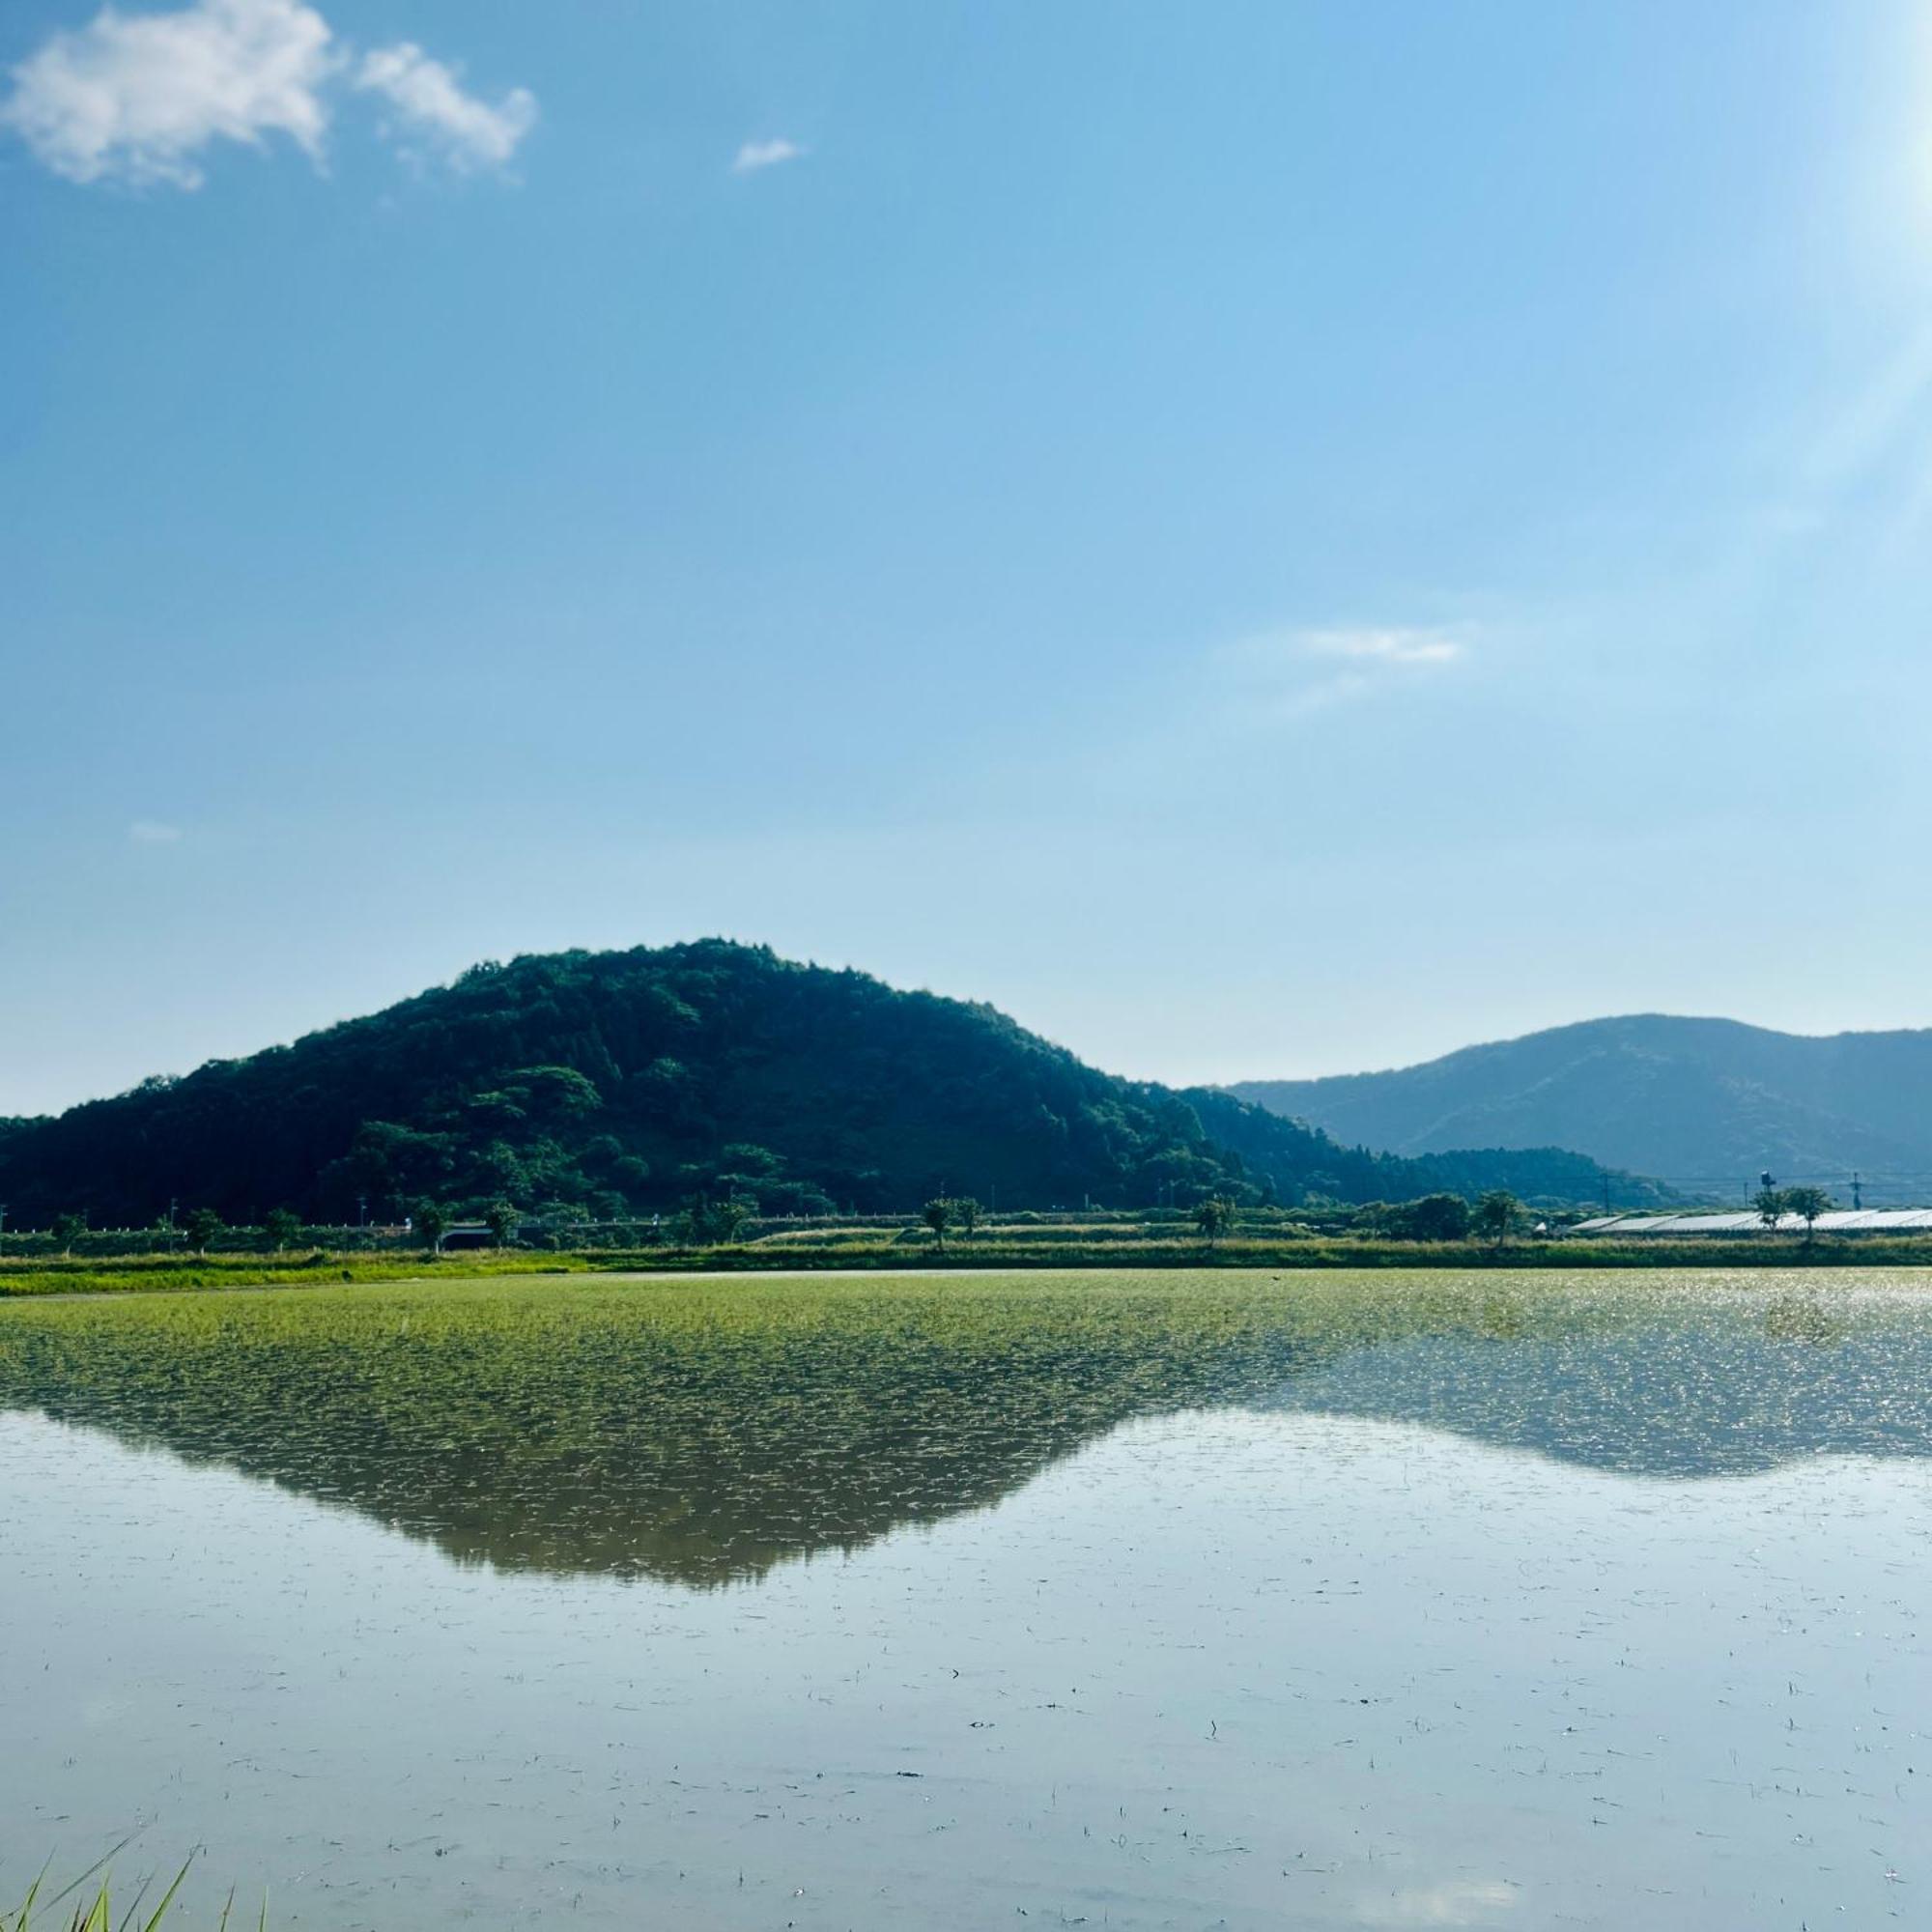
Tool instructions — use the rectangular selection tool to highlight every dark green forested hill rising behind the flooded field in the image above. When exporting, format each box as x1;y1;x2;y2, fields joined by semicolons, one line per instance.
0;941;1658;1227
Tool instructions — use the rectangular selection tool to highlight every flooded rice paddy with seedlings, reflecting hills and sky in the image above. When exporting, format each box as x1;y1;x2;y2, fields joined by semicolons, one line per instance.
0;1271;1932;1932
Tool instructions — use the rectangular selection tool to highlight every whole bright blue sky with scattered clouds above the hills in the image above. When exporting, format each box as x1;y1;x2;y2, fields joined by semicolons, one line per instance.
0;0;1932;1113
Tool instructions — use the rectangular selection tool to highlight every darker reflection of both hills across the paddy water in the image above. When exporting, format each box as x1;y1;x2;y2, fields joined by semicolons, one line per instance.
0;1277;1932;1588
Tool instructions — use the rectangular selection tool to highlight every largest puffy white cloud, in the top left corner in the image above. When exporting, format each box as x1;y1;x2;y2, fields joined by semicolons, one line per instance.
0;0;336;187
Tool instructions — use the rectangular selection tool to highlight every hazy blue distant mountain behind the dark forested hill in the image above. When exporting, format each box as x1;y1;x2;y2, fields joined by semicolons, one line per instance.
1229;1014;1932;1206
